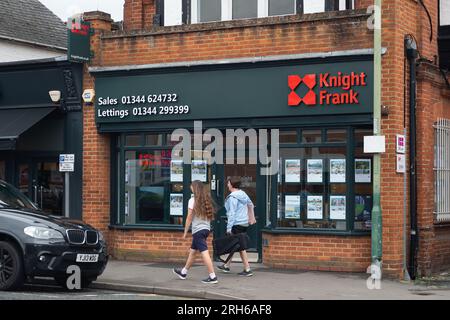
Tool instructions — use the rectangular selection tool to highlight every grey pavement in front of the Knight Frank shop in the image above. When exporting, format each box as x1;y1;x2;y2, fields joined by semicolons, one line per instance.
92;260;450;300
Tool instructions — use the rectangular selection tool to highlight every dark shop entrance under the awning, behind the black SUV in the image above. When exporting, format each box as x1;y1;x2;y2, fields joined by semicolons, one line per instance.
17;159;64;216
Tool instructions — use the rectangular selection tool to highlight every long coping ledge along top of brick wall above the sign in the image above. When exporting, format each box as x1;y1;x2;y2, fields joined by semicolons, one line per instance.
102;9;370;39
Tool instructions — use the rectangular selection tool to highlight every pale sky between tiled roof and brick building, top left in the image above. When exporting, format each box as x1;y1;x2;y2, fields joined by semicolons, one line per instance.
39;0;125;21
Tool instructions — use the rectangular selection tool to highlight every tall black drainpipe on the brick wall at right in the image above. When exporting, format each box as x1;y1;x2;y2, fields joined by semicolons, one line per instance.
405;36;419;279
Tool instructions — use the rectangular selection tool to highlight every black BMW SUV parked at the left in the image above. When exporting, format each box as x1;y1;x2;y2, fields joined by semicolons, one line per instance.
0;180;108;290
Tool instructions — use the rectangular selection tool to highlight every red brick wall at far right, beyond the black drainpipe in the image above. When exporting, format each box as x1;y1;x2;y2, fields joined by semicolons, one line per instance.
416;63;450;276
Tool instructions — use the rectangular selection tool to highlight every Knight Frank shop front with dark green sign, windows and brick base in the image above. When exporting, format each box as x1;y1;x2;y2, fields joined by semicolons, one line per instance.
90;54;373;271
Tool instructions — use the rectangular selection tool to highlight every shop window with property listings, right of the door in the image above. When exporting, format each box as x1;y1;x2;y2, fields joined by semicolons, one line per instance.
276;128;372;231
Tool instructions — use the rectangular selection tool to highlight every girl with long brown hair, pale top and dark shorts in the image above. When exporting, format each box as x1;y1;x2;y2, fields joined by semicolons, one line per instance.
173;180;218;283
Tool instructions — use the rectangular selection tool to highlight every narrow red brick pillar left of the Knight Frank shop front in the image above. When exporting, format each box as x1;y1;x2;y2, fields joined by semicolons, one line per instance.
83;11;112;232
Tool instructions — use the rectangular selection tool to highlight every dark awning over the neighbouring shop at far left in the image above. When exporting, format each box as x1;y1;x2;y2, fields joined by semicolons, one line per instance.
0;108;55;150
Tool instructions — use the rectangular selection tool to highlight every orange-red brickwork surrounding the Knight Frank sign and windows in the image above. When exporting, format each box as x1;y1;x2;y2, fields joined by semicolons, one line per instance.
83;0;449;277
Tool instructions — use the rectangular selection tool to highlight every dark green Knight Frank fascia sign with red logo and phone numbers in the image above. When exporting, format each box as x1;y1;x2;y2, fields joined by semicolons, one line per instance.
95;57;373;124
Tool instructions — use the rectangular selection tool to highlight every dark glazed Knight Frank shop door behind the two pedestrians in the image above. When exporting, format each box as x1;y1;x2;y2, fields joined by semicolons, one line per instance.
213;163;265;261
